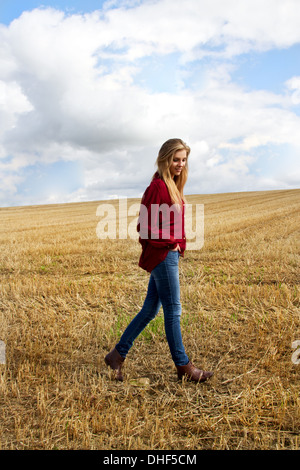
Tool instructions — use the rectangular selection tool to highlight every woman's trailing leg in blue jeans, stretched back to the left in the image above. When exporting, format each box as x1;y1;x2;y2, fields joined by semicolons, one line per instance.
116;274;161;358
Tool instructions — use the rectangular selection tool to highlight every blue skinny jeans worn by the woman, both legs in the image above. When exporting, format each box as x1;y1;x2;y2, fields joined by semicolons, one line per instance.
116;251;189;366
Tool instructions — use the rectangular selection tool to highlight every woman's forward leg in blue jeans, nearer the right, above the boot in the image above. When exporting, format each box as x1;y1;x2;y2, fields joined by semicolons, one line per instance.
151;251;189;366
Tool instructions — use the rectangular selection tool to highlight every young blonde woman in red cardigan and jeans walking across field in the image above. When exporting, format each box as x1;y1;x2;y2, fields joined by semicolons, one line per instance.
105;139;213;382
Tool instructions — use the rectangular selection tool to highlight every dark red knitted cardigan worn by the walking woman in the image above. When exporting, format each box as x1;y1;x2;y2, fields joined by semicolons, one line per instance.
137;173;186;272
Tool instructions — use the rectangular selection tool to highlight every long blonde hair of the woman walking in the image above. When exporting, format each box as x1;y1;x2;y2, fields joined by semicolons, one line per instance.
153;139;191;206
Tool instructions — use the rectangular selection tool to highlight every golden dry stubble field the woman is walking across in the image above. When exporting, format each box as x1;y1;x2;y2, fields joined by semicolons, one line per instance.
0;190;300;450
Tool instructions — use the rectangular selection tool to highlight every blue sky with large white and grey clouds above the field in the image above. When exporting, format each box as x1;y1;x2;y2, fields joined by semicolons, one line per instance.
0;0;300;207
